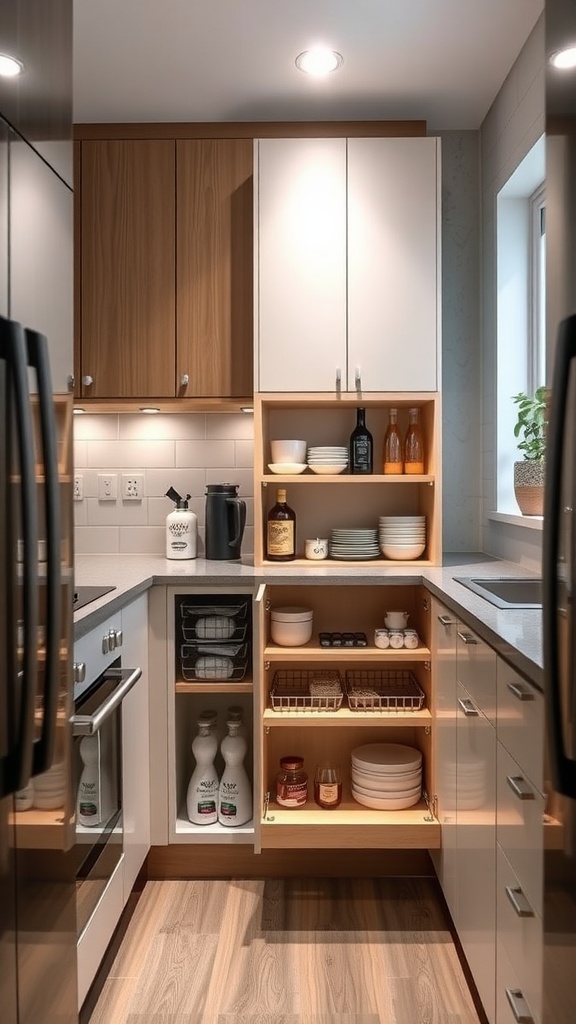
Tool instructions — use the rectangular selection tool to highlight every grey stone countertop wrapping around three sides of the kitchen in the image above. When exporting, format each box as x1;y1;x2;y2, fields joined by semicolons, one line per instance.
74;553;543;690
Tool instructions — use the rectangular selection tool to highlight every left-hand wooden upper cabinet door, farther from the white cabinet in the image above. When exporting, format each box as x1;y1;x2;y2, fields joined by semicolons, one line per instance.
80;139;175;398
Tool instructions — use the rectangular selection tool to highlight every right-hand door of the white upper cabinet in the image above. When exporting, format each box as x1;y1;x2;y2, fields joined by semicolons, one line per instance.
347;138;439;391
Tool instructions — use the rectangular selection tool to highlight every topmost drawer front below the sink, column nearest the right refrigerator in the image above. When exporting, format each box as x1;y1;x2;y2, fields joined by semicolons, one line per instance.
496;658;544;790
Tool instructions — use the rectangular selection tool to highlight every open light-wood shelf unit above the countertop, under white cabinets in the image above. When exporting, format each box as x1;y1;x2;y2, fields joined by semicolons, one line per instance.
254;392;442;569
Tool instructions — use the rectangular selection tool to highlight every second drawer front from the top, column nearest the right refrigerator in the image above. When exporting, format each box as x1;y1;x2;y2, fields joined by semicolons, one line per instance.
496;743;544;918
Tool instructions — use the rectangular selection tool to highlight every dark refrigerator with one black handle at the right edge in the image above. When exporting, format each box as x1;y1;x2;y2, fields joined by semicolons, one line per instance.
542;0;576;1024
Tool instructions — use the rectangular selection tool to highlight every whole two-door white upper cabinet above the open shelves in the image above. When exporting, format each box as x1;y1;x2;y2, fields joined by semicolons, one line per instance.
254;137;440;392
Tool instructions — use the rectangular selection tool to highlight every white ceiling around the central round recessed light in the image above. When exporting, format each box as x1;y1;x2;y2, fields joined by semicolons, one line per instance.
74;0;543;129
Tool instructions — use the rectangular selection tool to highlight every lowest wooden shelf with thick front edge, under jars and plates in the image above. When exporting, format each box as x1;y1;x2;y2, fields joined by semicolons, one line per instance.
261;800;441;850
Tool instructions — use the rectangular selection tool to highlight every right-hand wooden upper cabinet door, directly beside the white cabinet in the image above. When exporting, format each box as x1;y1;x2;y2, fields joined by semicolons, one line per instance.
176;139;253;397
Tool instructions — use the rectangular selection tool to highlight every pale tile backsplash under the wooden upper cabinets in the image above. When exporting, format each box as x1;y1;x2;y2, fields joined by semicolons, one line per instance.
74;413;254;555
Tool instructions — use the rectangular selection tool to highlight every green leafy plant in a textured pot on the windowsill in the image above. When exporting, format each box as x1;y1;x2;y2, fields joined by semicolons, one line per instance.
512;385;547;515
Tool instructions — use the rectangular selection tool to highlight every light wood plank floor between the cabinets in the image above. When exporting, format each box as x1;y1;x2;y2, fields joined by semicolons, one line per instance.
85;879;480;1024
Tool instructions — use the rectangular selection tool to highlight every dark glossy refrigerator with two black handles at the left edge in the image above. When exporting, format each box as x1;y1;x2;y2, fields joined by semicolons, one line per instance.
0;0;78;1024
